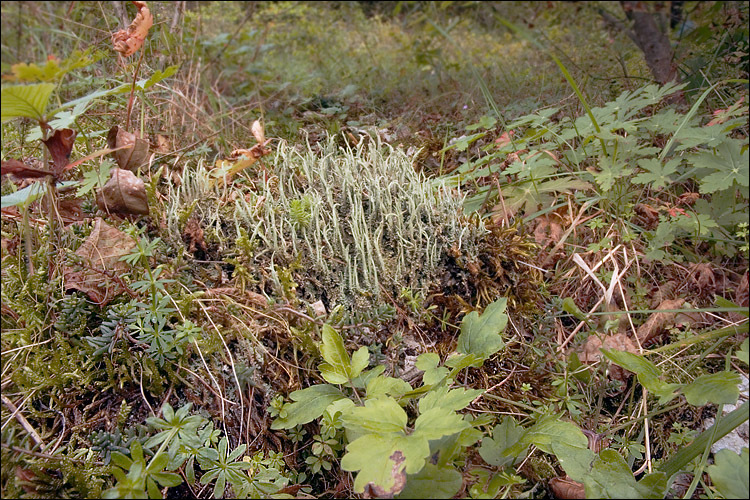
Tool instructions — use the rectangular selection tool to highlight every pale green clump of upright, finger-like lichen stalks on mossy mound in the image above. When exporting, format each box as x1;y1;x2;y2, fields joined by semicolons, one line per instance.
170;137;484;307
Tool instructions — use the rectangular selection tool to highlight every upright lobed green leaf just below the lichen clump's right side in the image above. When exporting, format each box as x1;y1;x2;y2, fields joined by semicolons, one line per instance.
457;297;508;359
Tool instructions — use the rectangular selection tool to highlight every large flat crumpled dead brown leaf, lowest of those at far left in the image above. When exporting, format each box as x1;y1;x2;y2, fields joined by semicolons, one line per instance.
63;217;136;305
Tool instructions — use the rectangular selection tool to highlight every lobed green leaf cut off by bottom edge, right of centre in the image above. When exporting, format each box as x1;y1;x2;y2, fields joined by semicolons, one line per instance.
582;450;667;498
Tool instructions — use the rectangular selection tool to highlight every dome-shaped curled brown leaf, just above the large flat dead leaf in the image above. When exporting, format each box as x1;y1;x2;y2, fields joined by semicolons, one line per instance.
96;168;148;216
